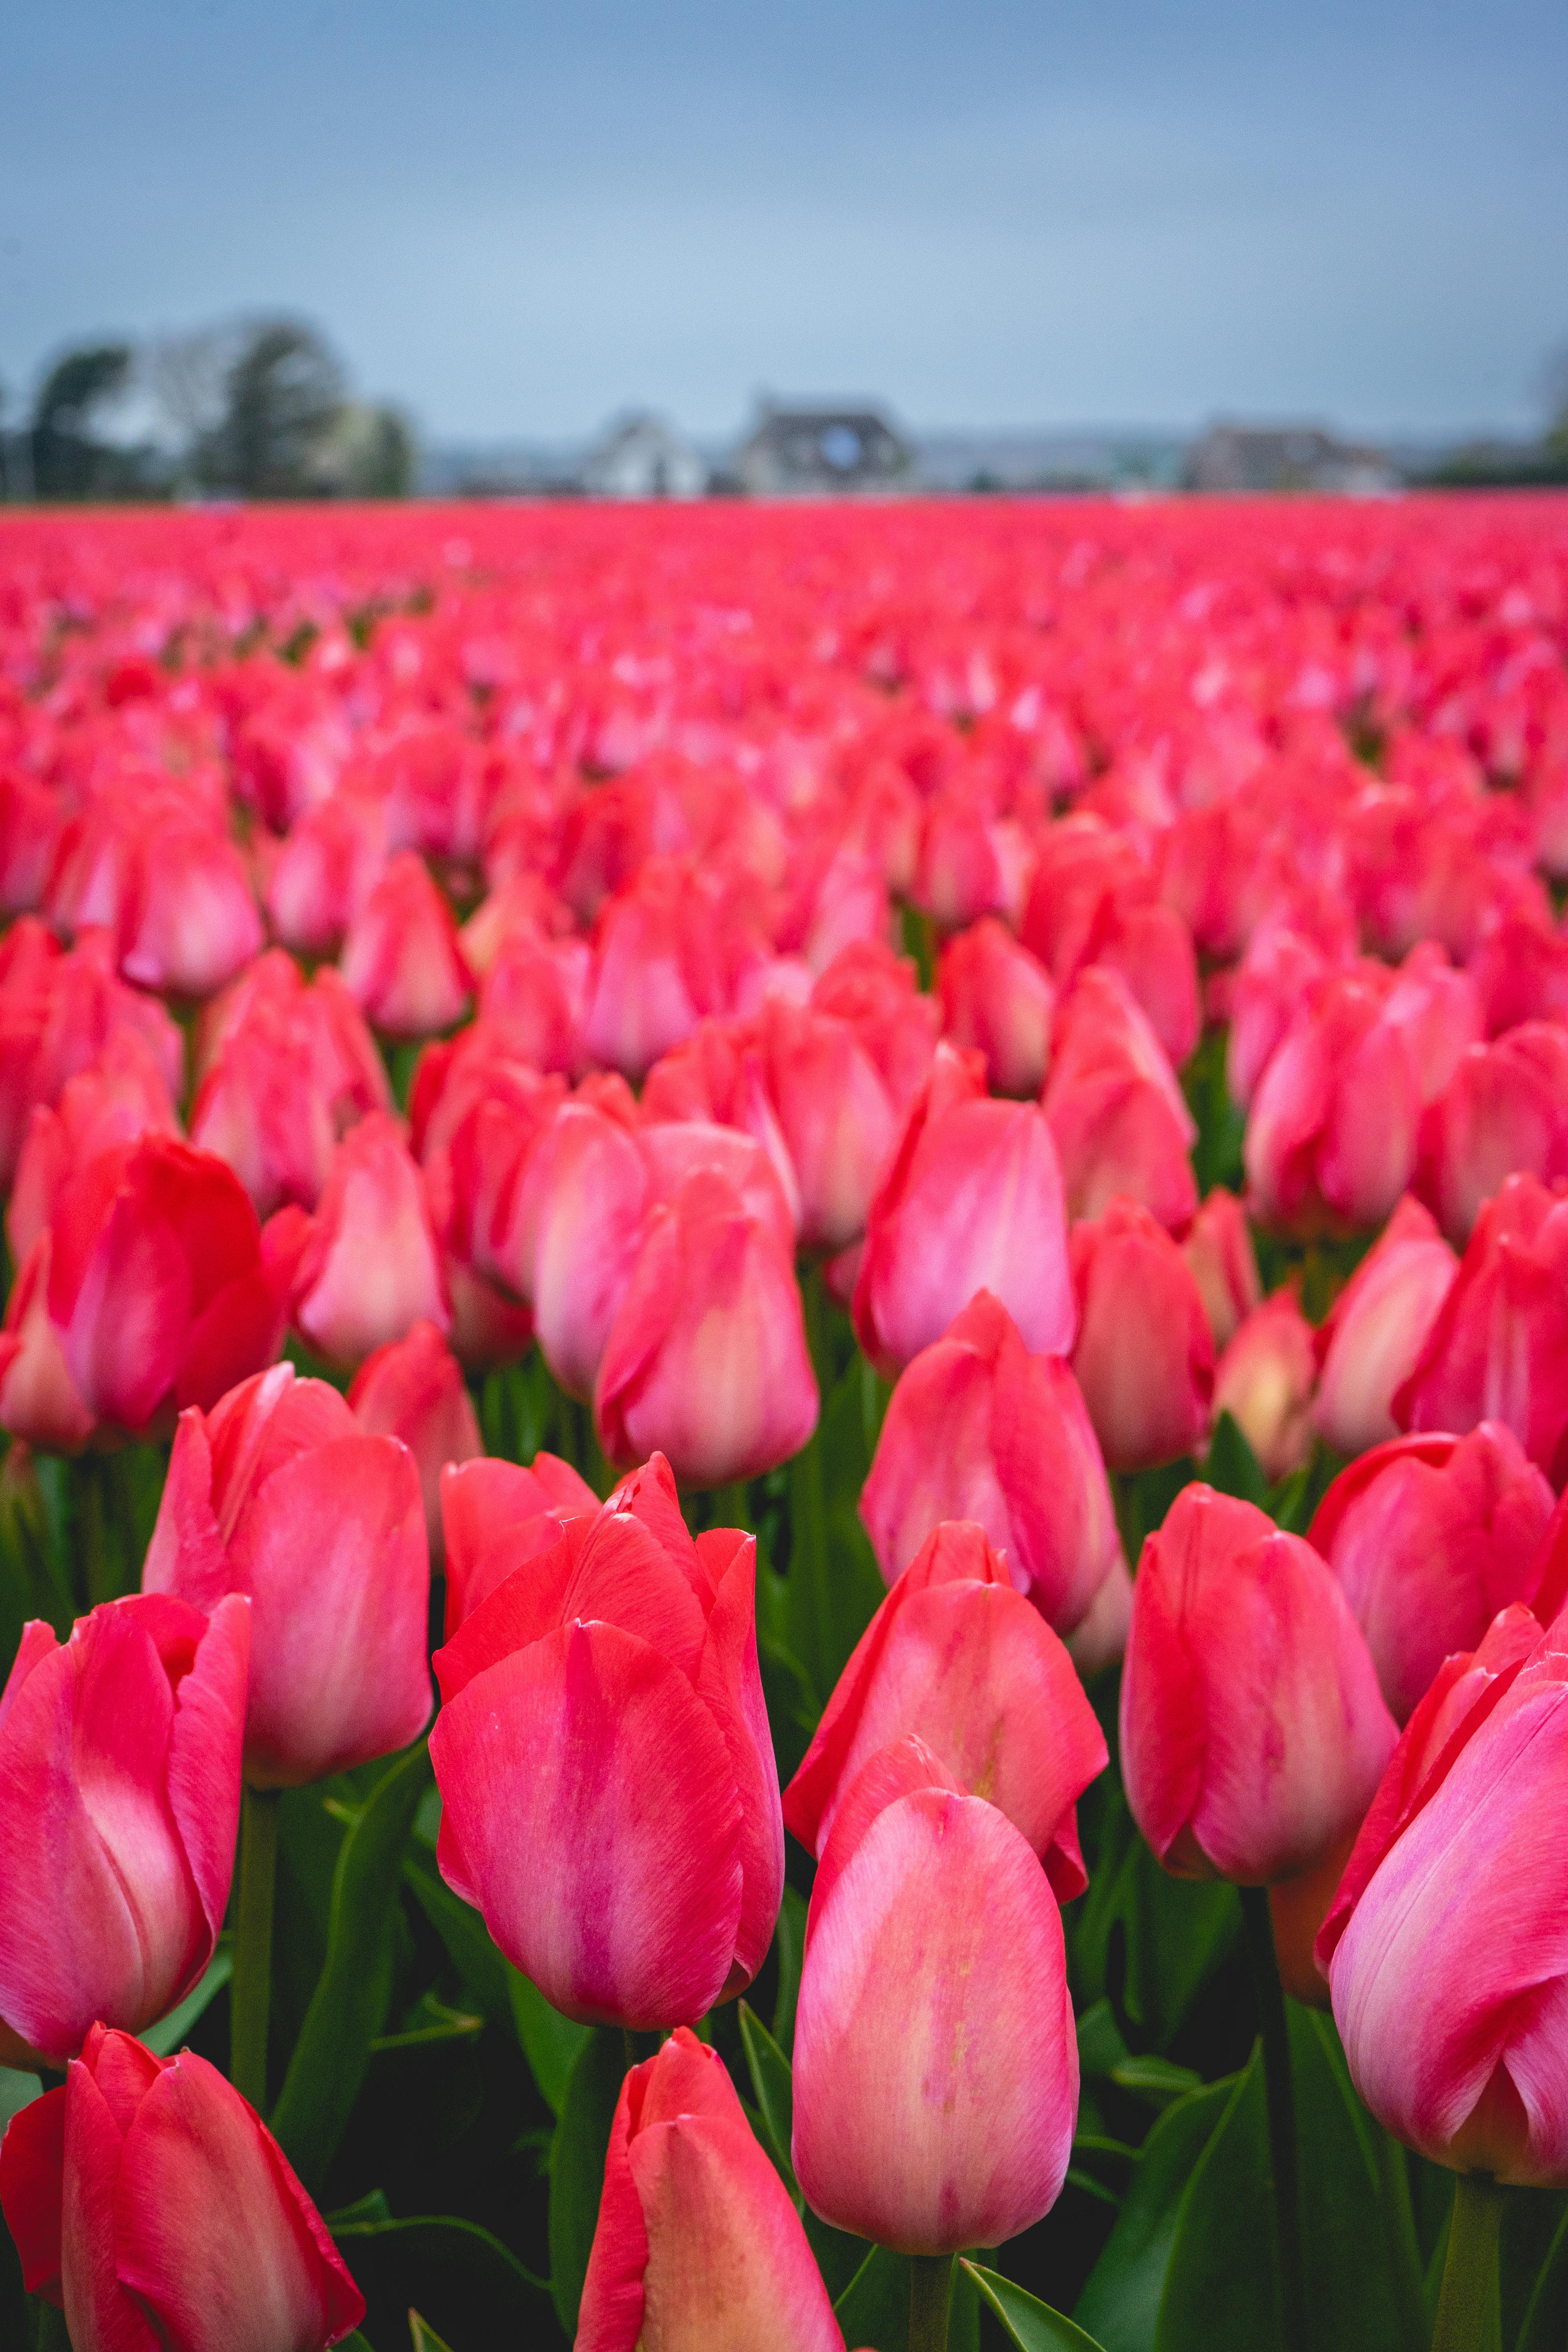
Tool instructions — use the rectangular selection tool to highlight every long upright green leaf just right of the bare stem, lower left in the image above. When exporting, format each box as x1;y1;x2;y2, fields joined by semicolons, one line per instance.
273;1741;430;2190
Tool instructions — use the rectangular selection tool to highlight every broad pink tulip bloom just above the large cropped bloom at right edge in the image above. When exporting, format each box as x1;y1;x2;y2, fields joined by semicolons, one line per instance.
1307;1421;1551;1724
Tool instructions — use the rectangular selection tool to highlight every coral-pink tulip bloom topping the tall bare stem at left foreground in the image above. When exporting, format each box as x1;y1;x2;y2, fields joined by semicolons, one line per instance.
141;1364;430;1787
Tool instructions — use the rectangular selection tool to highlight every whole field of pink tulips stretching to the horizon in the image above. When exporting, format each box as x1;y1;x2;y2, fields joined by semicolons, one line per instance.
0;496;1568;2352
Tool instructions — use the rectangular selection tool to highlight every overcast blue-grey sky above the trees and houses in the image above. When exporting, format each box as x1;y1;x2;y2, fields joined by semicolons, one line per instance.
0;0;1568;440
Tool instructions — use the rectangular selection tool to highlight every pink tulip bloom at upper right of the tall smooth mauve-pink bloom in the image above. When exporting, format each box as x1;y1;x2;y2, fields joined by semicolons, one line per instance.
1041;967;1197;1233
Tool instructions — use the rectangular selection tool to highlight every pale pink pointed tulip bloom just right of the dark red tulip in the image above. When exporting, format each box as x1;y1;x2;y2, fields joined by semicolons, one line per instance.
294;1110;449;1369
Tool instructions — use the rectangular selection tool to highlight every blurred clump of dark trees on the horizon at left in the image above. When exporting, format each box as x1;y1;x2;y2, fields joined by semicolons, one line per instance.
0;317;416;501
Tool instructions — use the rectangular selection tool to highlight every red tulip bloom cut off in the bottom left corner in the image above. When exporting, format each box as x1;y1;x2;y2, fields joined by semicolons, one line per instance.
0;2025;364;2352
